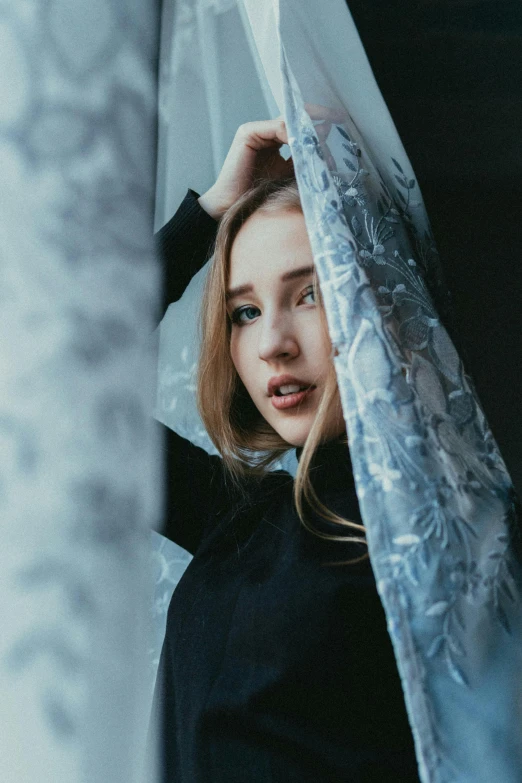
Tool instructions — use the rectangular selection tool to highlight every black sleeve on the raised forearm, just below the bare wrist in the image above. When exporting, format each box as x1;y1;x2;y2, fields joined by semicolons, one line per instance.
155;188;218;320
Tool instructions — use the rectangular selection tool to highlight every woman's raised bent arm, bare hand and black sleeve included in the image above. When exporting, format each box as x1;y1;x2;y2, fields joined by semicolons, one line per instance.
155;118;293;554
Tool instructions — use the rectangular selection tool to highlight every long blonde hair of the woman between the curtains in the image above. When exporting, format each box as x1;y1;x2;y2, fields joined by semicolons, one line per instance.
197;178;367;565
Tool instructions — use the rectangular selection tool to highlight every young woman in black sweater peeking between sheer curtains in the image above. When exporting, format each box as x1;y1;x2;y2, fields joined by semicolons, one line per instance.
151;119;418;783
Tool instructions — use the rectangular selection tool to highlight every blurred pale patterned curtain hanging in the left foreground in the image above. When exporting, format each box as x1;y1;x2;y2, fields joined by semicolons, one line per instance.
0;0;162;783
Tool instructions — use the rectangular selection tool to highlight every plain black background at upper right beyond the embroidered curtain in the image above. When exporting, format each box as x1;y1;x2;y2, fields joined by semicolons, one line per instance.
348;0;522;493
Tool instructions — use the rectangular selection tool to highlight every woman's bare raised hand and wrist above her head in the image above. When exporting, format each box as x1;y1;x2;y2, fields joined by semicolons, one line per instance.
199;117;294;220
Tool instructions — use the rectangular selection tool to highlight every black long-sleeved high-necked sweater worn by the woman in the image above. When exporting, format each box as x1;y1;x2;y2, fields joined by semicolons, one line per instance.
155;190;419;783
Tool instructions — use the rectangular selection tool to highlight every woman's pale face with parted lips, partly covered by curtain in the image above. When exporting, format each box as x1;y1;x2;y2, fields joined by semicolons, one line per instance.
227;210;345;446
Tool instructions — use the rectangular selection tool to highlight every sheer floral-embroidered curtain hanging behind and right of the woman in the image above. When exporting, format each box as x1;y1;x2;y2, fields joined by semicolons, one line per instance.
157;0;522;783
